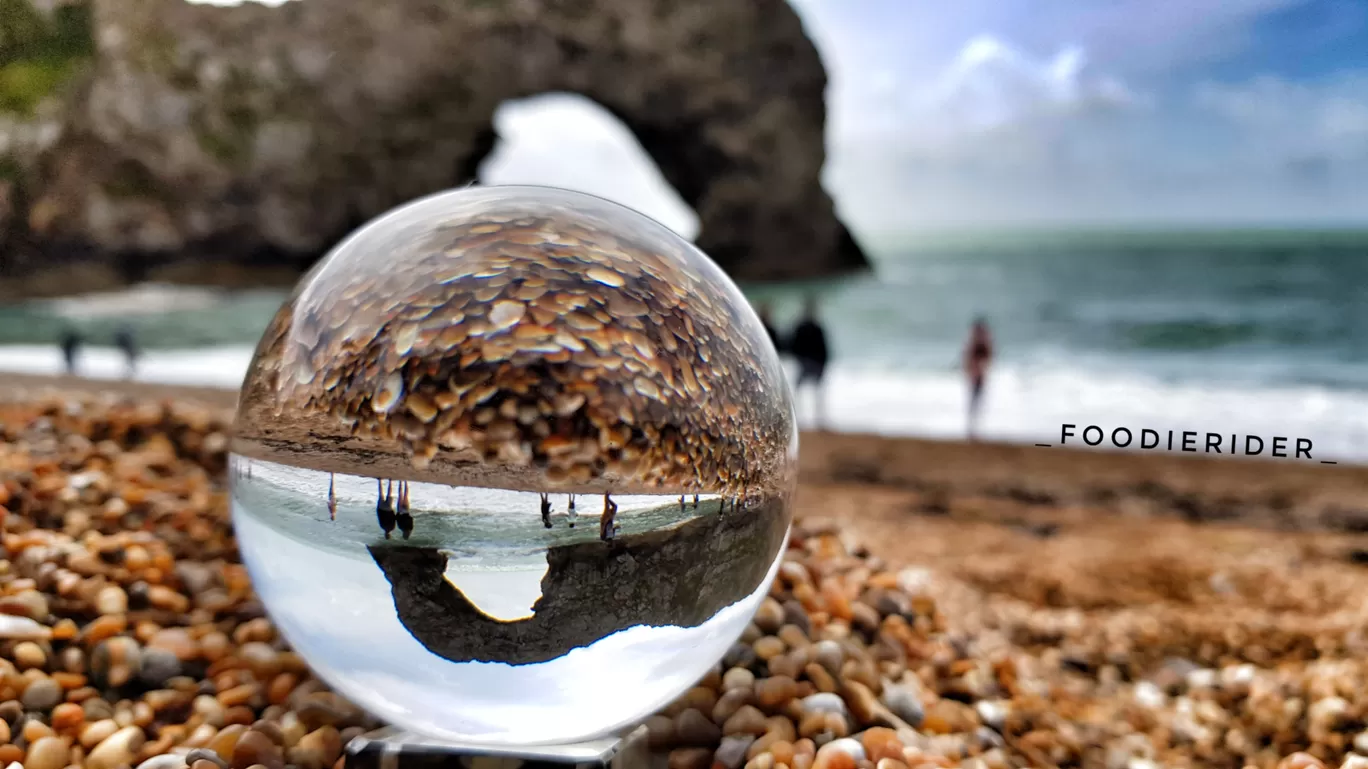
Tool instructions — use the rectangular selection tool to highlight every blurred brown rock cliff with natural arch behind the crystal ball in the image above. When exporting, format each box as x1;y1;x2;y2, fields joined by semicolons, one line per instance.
0;0;866;294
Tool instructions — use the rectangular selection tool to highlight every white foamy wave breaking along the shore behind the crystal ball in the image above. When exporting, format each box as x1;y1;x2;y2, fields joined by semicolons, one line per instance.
0;345;1368;462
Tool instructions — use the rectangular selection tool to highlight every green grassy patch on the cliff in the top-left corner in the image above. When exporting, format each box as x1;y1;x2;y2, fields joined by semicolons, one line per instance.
0;0;94;116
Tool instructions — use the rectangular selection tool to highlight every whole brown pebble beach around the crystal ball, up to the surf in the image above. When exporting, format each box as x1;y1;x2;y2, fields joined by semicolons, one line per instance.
0;376;1368;769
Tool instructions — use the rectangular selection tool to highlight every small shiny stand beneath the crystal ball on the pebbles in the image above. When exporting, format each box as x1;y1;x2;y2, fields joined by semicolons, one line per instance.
343;727;653;769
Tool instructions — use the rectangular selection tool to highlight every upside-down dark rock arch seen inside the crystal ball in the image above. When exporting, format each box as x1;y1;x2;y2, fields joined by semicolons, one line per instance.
367;499;789;665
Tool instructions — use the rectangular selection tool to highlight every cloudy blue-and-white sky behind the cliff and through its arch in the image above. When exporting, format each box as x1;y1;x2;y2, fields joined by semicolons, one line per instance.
482;0;1368;239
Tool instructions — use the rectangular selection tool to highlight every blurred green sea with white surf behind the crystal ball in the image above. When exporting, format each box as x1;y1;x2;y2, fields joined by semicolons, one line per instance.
0;224;1368;464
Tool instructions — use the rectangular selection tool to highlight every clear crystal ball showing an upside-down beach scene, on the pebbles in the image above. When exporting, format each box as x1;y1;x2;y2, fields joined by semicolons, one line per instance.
230;186;798;746
